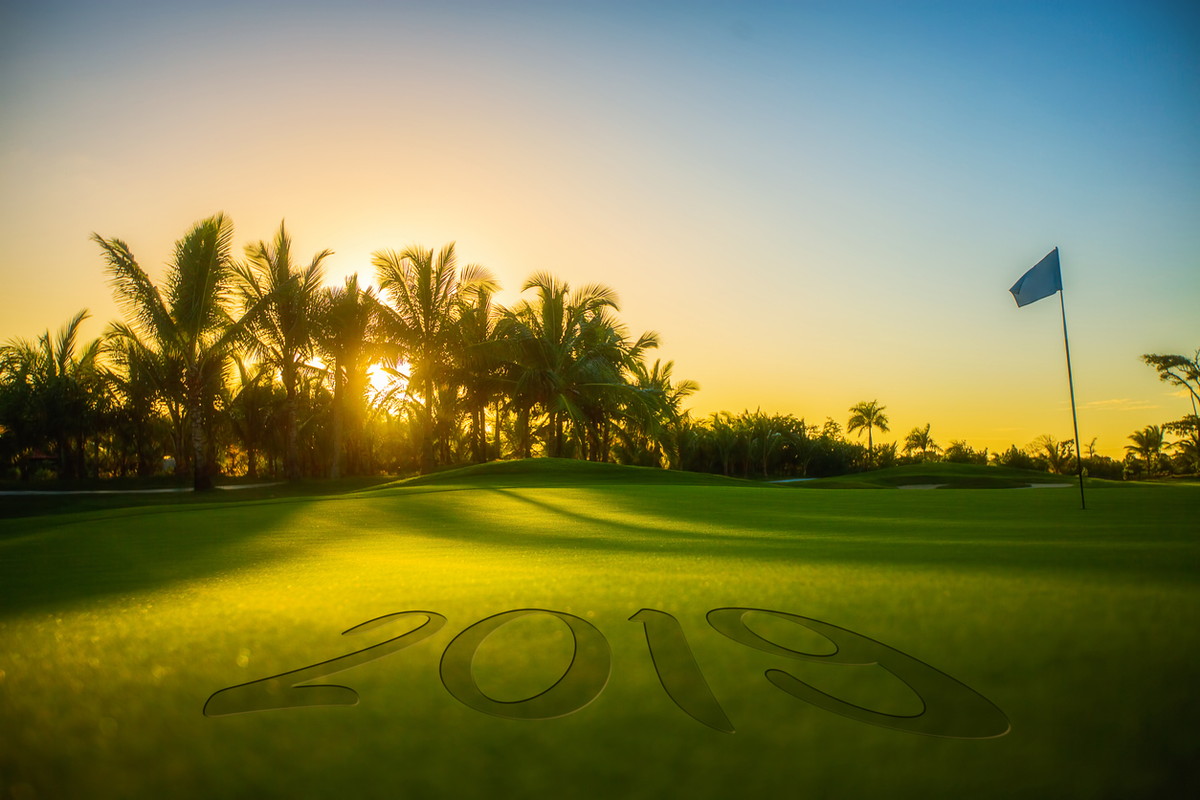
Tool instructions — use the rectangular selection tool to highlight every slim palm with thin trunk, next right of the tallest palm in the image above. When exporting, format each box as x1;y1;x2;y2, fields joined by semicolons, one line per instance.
234;222;332;481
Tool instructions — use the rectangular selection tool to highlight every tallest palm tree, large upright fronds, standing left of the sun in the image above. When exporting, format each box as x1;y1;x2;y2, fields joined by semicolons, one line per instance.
92;213;260;492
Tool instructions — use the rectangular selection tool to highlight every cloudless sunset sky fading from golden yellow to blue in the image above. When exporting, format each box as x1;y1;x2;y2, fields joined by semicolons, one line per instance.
0;0;1200;456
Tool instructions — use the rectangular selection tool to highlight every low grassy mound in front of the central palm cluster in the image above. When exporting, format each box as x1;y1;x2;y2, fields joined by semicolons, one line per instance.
388;458;763;488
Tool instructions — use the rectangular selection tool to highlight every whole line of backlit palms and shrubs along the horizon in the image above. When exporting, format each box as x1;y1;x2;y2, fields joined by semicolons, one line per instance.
0;213;1200;489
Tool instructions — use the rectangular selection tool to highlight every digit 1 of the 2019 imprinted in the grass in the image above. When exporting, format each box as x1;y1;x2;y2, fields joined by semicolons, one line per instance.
629;608;733;733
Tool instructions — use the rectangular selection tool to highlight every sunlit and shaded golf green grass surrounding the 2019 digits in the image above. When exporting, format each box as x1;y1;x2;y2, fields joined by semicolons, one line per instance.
0;463;1200;798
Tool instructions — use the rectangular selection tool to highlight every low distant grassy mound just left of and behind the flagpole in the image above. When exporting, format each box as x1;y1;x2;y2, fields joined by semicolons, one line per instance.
796;462;1075;489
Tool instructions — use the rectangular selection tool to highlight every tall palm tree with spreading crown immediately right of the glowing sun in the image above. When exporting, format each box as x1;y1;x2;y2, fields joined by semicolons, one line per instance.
371;242;498;471
